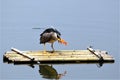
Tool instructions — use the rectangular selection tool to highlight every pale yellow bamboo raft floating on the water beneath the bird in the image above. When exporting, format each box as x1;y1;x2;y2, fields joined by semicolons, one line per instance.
3;48;114;64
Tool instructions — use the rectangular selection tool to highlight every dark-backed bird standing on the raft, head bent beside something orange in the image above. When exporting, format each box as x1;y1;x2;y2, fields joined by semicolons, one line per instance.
40;28;67;53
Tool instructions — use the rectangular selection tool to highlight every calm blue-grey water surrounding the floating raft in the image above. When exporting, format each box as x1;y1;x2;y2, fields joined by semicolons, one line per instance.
0;0;120;80
